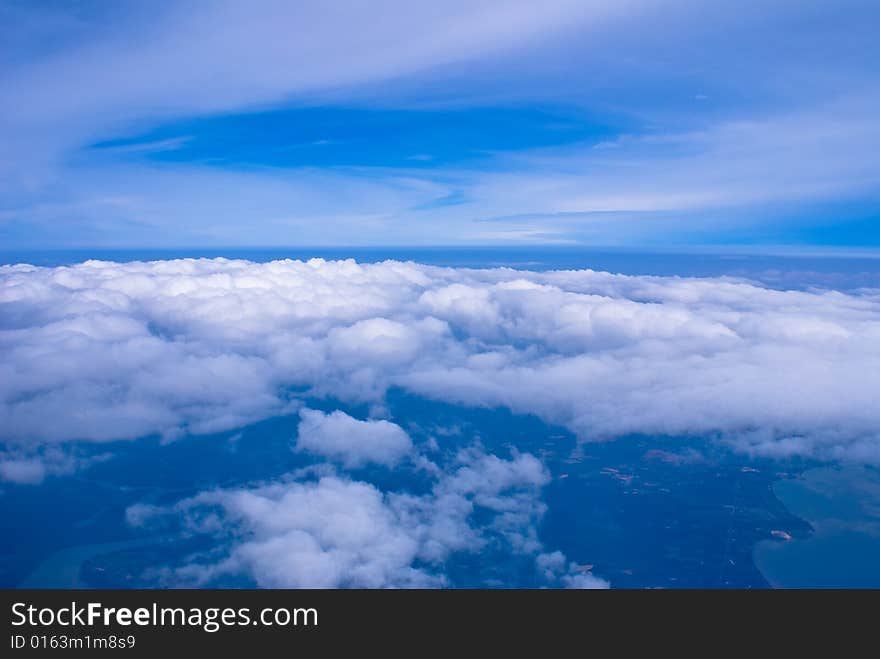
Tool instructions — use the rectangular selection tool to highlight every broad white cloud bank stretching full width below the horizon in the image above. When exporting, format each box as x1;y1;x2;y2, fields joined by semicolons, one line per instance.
0;259;880;472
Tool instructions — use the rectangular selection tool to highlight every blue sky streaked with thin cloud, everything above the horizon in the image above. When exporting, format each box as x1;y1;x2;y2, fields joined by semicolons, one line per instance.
0;0;880;249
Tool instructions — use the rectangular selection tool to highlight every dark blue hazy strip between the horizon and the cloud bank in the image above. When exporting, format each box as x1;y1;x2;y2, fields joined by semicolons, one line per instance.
0;245;880;291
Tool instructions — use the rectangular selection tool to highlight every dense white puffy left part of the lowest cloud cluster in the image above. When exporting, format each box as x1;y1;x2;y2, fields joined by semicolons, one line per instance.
170;477;439;588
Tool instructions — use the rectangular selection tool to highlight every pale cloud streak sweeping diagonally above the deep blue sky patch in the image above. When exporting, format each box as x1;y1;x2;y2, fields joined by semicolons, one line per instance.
3;0;620;129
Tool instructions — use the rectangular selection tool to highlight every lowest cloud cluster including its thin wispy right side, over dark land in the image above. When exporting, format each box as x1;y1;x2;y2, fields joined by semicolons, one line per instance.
128;449;603;588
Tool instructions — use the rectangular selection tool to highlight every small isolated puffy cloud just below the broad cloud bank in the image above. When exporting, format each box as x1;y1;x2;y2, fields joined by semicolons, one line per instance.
296;409;413;469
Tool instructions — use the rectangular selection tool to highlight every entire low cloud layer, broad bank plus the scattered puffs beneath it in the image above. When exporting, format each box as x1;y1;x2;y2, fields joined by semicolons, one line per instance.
0;259;880;587
